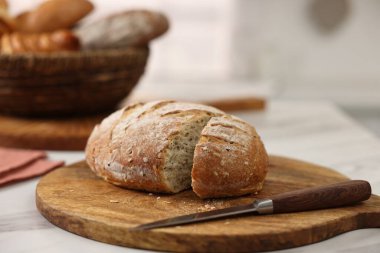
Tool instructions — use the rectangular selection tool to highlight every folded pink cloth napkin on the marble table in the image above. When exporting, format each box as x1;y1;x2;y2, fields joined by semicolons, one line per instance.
0;147;64;187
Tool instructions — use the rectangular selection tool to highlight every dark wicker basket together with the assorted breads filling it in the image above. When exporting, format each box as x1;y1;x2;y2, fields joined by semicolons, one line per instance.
0;6;169;116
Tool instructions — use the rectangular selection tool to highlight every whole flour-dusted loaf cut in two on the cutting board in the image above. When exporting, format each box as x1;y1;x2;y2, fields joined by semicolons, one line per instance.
86;101;268;198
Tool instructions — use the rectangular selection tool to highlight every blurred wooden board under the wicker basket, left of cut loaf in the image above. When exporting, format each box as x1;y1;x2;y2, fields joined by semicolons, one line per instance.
0;115;106;150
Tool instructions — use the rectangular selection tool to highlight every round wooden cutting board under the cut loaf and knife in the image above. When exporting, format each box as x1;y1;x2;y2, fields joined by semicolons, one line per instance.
36;156;380;252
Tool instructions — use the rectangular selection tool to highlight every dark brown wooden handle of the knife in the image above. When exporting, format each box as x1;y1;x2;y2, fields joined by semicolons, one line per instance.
272;180;371;213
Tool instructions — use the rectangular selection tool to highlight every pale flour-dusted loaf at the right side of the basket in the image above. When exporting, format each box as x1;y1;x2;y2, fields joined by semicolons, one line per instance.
76;10;169;49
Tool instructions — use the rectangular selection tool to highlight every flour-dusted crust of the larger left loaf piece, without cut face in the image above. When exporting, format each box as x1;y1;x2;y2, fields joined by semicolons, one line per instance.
86;101;223;193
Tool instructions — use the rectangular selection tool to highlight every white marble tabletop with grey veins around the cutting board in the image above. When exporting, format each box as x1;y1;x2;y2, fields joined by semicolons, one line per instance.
0;101;380;253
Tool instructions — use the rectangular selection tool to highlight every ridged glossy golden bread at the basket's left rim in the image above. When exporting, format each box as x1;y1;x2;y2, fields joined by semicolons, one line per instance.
0;30;80;54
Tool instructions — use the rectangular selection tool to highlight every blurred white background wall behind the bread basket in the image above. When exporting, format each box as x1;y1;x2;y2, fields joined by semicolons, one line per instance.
11;0;380;104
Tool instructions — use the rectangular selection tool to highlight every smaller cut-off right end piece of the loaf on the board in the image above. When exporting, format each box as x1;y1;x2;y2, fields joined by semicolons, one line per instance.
192;115;268;198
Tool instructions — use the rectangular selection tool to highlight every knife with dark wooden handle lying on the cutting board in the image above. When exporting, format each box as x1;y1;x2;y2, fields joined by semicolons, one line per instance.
130;180;371;231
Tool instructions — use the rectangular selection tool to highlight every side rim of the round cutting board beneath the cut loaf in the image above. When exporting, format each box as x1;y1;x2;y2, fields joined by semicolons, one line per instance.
36;156;380;252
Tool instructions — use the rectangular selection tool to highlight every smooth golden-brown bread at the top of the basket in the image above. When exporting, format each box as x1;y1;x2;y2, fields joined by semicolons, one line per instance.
16;0;94;33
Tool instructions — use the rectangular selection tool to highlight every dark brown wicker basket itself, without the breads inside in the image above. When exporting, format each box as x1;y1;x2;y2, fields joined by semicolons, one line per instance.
0;47;149;117
